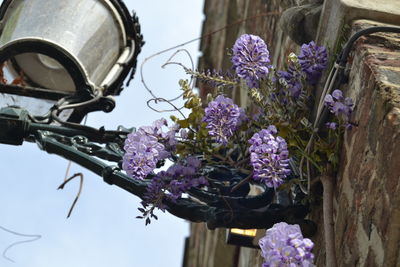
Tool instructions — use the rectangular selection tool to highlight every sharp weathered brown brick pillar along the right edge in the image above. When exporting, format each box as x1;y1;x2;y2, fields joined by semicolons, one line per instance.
332;21;400;266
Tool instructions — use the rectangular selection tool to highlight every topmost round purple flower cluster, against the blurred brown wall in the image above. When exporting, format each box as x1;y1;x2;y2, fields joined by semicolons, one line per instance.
231;34;270;88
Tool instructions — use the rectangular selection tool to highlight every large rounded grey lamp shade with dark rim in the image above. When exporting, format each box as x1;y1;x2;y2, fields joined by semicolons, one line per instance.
0;0;141;95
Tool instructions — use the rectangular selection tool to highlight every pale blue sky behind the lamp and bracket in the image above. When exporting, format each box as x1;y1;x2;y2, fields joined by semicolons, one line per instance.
0;0;203;267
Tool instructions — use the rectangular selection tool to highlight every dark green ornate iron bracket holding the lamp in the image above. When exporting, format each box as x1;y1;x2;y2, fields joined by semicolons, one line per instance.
0;107;315;235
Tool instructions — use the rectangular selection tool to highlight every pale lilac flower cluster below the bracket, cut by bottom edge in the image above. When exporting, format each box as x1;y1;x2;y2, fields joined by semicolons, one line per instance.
259;222;314;267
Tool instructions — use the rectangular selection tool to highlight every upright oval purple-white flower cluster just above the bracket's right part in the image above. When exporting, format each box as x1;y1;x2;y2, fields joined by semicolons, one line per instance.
249;125;290;188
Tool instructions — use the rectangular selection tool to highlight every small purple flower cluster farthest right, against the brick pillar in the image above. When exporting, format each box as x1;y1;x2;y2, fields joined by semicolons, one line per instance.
324;90;353;125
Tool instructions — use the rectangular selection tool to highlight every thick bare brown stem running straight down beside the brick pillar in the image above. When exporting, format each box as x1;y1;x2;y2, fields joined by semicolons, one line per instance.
320;172;337;267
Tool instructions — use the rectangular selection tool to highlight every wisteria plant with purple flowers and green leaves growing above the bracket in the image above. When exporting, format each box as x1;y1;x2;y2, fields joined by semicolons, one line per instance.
123;34;353;266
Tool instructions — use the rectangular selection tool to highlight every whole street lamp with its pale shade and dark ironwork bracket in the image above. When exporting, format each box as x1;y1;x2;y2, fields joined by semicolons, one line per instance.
0;0;315;234
